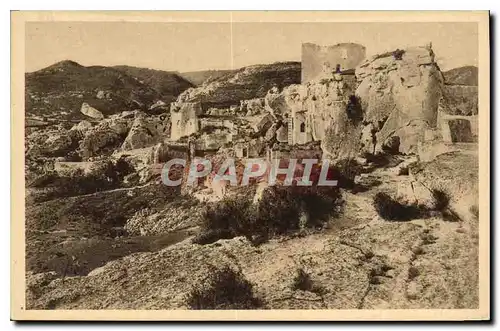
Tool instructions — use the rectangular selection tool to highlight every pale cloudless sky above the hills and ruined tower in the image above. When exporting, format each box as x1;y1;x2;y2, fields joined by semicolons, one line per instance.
25;22;478;72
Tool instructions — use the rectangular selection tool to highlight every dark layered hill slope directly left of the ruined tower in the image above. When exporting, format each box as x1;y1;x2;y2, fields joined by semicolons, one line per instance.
180;62;301;110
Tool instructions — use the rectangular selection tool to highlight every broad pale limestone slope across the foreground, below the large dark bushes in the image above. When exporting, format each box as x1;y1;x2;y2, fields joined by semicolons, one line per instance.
28;219;479;309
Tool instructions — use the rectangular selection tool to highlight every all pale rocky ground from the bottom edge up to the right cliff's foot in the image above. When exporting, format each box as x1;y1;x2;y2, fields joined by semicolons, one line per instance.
27;151;478;309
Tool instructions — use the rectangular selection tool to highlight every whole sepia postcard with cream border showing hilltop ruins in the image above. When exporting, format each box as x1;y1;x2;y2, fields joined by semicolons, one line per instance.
11;11;490;320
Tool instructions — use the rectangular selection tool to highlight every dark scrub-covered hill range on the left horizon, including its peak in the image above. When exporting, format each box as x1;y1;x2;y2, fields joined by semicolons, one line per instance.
25;61;191;119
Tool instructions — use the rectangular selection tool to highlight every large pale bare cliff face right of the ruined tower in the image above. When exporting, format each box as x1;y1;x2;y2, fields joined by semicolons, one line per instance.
356;46;443;153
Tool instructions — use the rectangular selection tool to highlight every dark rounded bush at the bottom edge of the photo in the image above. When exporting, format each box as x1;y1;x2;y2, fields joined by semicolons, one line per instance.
187;266;260;309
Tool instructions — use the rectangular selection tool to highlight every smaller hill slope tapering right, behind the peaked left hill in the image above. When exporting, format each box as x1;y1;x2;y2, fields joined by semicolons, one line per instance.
113;66;193;103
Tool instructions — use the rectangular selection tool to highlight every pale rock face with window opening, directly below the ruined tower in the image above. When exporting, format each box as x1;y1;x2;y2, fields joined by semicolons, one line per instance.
266;74;363;159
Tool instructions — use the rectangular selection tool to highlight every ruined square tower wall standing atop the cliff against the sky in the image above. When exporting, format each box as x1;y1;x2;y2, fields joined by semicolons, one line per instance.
301;43;366;84
